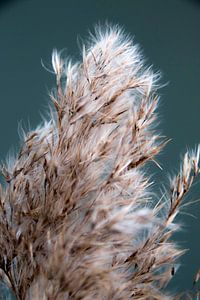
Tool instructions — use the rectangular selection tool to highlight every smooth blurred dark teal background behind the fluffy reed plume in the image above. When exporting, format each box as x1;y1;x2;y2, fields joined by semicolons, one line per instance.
0;0;200;296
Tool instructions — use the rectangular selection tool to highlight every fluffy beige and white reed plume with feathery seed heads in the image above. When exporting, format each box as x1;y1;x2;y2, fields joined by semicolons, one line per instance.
0;27;200;300
